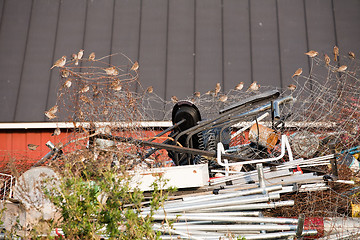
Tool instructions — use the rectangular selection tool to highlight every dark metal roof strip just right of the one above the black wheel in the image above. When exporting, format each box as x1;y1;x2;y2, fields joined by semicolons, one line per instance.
195;0;224;92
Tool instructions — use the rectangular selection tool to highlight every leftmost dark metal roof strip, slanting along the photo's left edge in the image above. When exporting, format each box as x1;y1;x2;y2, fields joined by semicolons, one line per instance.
0;0;32;122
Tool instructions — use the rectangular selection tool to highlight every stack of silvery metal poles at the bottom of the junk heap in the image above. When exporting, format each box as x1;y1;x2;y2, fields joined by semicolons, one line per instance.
142;164;317;239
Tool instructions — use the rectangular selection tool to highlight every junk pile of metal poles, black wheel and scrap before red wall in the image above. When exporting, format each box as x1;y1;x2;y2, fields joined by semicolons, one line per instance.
0;90;360;239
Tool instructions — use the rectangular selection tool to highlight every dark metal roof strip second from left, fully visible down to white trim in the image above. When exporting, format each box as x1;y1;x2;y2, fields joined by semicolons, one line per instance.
14;0;59;121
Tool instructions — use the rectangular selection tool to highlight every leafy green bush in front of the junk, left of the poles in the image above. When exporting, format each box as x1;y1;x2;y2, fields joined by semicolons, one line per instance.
46;155;173;239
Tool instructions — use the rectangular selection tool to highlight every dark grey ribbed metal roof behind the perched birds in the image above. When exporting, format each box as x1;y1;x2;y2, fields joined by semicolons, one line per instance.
0;0;360;122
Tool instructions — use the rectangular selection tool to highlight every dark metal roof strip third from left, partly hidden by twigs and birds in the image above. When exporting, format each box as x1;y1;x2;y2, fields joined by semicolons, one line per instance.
44;0;89;121
